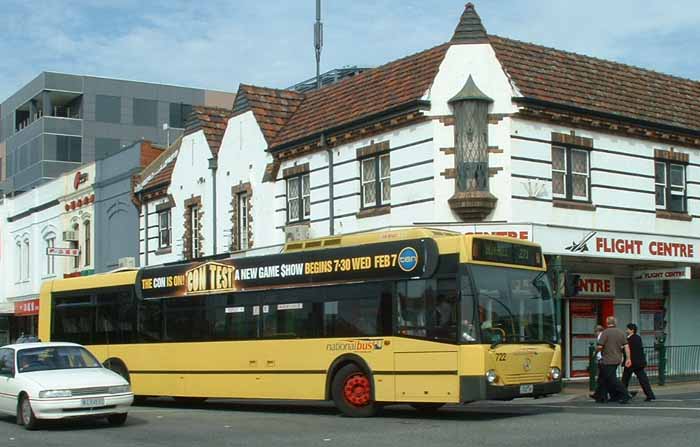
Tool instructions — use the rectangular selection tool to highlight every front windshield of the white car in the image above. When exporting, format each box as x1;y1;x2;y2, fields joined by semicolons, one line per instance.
17;346;102;373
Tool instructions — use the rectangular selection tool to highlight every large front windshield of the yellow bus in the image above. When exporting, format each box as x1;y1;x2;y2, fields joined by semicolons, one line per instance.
470;265;558;344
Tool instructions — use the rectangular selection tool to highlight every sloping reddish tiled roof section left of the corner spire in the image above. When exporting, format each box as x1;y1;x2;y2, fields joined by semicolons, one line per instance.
270;44;449;151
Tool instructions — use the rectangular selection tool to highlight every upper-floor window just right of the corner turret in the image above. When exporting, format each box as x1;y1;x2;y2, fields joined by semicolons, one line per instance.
552;146;590;201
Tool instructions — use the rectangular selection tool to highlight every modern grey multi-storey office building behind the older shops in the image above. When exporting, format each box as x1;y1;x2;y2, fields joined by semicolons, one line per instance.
0;72;235;194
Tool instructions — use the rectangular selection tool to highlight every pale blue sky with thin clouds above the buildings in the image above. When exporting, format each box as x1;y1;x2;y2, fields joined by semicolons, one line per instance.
0;0;700;102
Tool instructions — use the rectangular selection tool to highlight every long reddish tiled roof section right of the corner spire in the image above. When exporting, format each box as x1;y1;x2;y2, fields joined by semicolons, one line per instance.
489;36;700;130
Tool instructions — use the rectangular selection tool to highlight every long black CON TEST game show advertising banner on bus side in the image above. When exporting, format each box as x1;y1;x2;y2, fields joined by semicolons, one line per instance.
136;239;438;299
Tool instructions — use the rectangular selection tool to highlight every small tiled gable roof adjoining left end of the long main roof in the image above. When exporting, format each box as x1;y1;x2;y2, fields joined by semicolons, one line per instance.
233;84;304;145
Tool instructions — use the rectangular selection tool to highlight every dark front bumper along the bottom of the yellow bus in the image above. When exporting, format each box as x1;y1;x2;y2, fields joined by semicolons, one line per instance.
459;376;562;402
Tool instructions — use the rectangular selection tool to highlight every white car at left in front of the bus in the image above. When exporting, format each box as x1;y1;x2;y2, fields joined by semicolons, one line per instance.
0;343;134;430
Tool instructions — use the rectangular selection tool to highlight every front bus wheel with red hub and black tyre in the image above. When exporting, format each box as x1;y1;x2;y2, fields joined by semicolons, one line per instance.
331;363;378;418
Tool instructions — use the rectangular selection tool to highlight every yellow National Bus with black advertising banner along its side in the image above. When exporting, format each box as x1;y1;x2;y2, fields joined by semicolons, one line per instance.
39;228;561;417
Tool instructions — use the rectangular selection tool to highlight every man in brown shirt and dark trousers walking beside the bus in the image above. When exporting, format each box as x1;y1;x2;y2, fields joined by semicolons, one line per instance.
597;317;632;404
